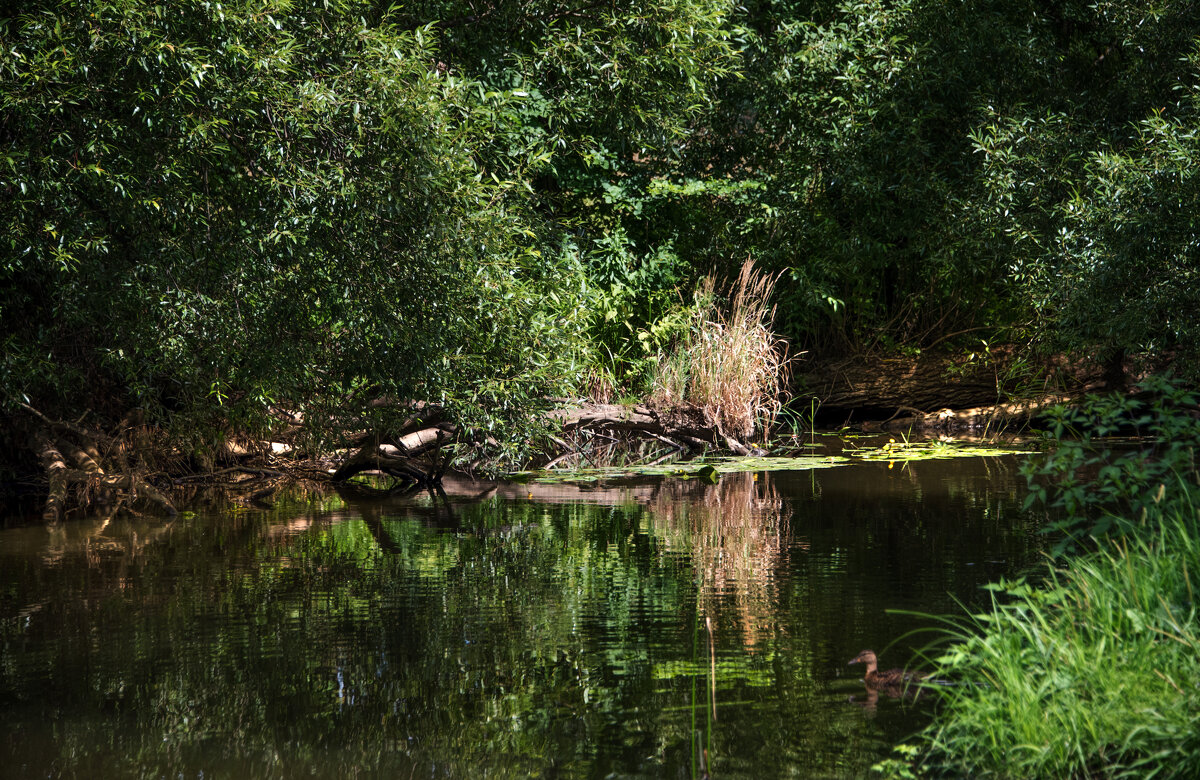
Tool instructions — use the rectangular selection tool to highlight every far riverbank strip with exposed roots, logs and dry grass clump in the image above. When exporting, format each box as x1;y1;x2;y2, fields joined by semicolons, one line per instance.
0;350;1180;523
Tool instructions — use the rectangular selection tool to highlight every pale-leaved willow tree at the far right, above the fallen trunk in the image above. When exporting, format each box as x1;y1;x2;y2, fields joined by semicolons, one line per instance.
972;2;1200;380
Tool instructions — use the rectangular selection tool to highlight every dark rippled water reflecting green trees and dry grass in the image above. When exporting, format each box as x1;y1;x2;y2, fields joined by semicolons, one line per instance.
0;457;1039;779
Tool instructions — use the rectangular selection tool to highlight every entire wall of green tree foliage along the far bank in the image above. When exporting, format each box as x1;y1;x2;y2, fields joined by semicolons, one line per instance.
0;0;1200;456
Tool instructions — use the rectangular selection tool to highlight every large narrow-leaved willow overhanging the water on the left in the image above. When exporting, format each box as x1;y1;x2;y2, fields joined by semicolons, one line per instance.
0;0;590;516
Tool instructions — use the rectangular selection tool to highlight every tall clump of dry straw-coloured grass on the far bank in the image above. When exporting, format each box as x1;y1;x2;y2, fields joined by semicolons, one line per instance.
652;260;790;442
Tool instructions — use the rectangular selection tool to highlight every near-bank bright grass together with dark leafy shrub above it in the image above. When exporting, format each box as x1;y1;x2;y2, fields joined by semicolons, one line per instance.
902;380;1200;778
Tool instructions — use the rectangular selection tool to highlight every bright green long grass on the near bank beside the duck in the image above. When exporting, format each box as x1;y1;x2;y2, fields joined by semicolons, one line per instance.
907;500;1200;778
